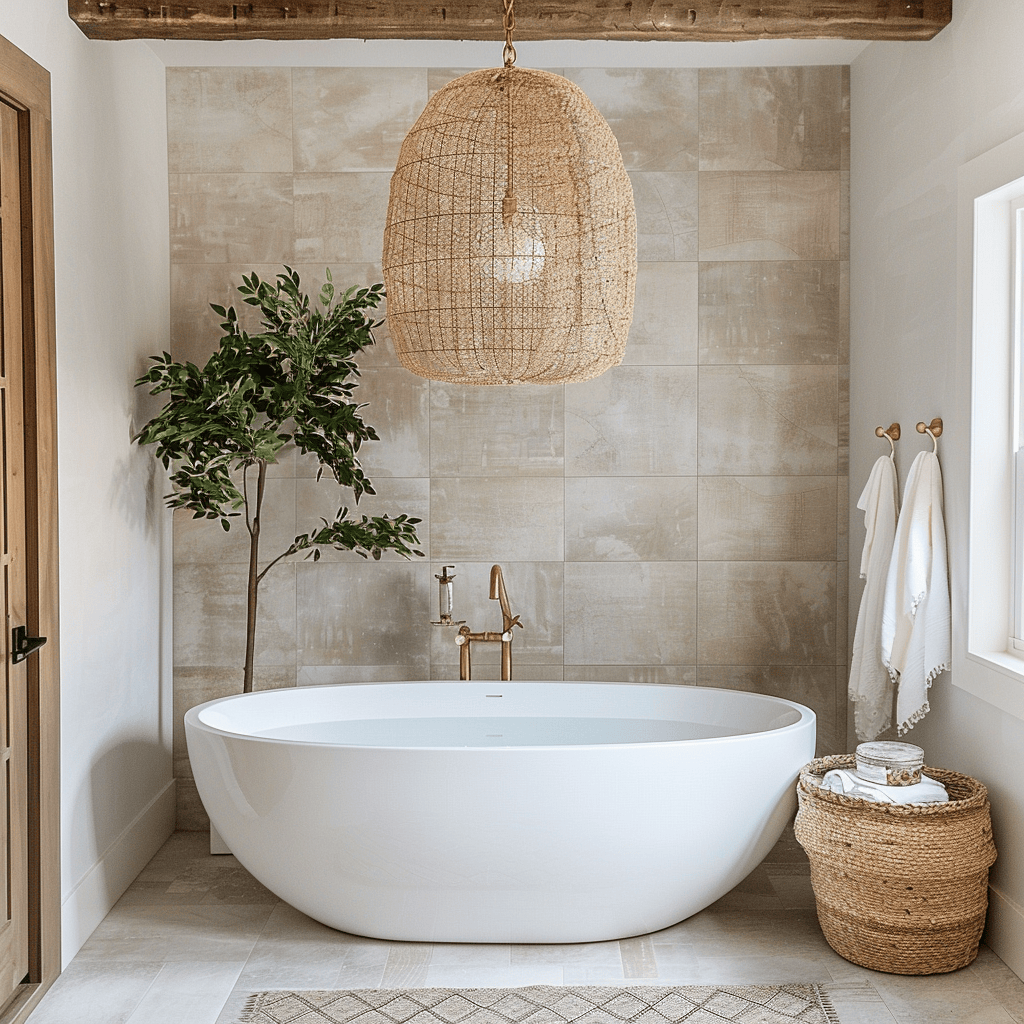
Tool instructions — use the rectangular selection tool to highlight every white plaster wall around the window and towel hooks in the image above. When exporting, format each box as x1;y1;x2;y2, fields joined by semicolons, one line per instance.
850;0;1024;975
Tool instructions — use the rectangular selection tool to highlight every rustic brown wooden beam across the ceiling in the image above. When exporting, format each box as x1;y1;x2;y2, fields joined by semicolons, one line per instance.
68;0;952;42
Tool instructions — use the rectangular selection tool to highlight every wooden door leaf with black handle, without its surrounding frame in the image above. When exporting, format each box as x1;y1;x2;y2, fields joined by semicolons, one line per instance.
0;100;29;1007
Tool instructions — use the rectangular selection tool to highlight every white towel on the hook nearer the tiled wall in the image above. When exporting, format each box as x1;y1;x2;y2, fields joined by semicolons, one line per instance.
850;455;899;740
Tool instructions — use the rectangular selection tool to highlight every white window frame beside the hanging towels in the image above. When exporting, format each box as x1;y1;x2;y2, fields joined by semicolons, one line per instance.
952;134;1024;719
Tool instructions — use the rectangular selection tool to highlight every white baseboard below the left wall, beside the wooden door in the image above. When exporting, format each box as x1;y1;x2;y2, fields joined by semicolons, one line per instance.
60;778;174;970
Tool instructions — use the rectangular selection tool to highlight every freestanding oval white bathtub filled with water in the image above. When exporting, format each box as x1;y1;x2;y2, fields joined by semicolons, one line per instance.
185;682;814;943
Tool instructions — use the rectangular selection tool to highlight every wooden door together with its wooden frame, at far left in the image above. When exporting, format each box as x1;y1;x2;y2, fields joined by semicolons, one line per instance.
0;29;60;1024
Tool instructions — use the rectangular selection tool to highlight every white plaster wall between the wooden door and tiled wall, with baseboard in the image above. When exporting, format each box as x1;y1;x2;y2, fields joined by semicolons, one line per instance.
0;0;173;963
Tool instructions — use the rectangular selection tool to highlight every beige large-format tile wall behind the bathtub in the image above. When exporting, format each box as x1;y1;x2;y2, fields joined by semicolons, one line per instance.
168;67;849;827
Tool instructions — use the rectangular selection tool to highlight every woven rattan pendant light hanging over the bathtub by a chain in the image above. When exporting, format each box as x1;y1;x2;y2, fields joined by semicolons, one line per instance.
383;0;636;384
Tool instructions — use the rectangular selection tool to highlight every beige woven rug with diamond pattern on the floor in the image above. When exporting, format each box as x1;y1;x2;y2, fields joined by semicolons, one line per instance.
240;985;840;1024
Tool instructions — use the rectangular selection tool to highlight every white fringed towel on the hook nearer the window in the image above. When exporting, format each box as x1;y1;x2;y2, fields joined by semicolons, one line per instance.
882;452;950;736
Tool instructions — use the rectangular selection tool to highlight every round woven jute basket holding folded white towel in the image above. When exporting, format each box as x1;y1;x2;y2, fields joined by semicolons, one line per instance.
796;755;995;974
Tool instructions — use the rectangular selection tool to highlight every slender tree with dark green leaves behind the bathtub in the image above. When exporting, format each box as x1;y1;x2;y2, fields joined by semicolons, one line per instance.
134;266;423;692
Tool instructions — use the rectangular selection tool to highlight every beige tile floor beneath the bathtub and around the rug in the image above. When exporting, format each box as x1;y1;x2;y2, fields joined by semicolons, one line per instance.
25;831;1024;1024
